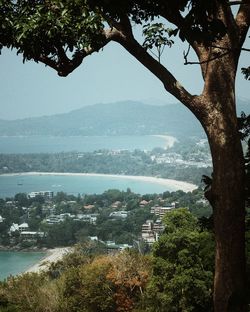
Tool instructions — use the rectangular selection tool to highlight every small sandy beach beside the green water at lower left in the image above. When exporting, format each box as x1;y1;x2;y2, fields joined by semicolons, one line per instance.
24;247;72;273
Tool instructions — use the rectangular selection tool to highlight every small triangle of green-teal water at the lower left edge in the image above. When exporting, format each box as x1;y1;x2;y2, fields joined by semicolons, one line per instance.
0;251;45;280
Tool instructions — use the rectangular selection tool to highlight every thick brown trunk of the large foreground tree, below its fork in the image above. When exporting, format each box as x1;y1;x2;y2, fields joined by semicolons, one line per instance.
201;92;246;312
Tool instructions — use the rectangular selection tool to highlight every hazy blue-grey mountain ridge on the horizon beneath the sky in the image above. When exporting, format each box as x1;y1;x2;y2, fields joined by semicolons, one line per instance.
0;101;249;137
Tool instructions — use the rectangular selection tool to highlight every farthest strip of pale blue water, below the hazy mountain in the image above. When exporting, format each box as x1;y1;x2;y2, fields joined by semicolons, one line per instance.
0;135;173;154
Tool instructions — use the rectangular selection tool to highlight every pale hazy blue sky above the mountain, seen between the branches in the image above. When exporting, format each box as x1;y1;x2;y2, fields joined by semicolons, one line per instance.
0;34;250;119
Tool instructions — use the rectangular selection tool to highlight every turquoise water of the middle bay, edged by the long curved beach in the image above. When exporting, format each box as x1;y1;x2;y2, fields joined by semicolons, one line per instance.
0;175;176;198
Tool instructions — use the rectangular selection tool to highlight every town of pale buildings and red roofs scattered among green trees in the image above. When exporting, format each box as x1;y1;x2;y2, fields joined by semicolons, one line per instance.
0;189;211;250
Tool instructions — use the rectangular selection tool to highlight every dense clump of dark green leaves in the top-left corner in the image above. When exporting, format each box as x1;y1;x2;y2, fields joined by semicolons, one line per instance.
0;0;103;69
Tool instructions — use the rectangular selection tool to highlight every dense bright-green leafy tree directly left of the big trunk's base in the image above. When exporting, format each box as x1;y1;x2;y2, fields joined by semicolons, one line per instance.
147;209;214;312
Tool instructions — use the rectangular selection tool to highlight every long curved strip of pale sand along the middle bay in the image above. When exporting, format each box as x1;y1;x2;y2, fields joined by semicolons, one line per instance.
0;171;198;192
